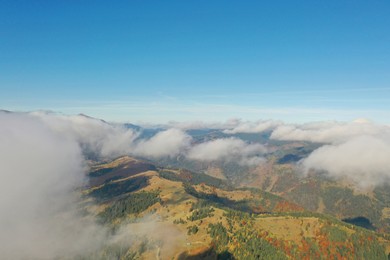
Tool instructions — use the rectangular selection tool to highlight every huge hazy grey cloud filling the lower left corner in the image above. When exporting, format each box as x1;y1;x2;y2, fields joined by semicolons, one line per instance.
0;112;102;259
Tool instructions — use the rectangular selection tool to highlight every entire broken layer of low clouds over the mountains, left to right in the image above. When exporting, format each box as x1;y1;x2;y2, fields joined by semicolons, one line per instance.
0;109;390;259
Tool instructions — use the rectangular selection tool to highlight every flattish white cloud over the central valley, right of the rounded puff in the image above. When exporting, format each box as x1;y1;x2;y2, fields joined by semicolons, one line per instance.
187;138;266;165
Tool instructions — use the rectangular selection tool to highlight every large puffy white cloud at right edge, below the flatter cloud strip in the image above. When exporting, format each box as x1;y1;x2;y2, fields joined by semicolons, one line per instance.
301;136;390;186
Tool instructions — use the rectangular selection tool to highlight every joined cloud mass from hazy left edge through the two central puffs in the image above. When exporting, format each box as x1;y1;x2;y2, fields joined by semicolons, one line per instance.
0;112;265;259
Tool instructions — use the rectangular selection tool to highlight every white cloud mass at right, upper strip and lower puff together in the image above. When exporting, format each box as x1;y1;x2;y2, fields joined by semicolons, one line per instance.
271;119;390;187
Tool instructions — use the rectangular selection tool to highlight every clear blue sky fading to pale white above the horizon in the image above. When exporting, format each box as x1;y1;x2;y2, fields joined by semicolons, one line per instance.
0;0;390;123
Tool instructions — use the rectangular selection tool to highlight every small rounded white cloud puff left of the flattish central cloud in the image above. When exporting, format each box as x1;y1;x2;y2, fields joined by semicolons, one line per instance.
132;129;191;157
